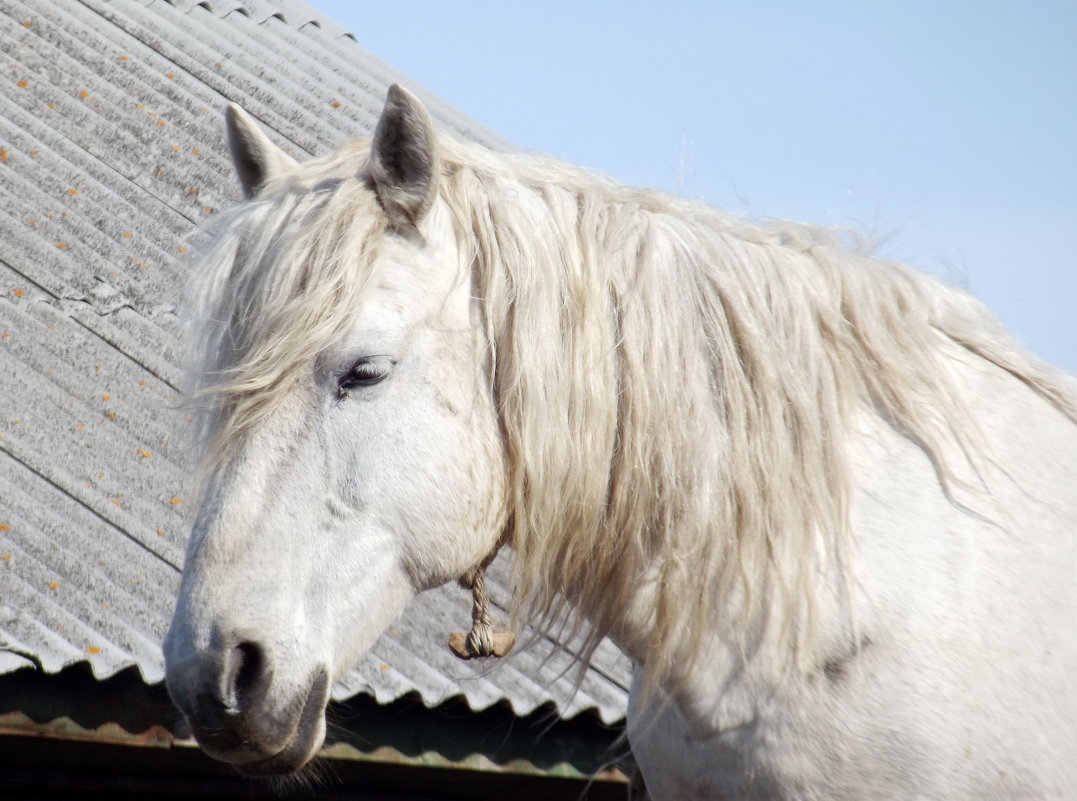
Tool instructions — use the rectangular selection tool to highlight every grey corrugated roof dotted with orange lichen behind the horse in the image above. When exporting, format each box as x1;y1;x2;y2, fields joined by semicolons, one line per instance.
0;0;629;722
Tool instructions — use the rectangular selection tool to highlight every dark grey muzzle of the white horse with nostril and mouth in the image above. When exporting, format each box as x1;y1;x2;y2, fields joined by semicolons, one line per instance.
166;641;328;776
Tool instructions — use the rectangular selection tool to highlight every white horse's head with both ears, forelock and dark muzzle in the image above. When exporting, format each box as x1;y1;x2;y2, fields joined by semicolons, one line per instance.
164;86;506;775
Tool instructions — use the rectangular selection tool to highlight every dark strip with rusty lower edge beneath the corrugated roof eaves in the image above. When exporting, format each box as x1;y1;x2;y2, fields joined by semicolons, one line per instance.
0;665;627;788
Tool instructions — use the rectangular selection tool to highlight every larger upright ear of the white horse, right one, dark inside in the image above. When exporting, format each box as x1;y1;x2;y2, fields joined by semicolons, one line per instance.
369;84;438;226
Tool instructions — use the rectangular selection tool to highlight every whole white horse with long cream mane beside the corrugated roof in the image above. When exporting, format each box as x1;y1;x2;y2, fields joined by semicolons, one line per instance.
165;87;1077;801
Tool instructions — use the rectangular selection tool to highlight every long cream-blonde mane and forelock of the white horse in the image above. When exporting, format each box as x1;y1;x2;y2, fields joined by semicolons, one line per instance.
189;132;1077;693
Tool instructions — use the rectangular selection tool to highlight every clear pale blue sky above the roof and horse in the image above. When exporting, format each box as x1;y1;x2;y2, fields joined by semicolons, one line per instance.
311;0;1077;370
